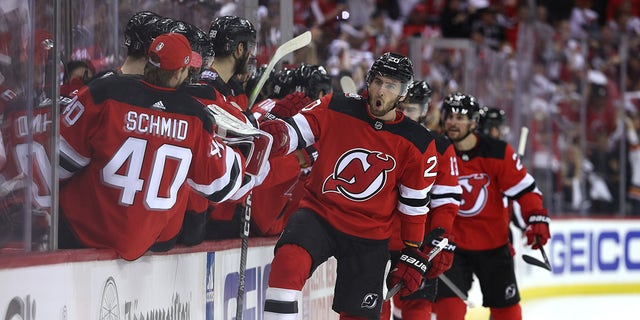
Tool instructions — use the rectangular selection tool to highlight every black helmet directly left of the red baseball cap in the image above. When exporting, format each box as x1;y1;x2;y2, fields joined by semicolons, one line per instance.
124;11;162;56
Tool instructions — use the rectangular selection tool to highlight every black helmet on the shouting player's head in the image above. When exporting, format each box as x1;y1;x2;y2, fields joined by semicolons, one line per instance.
366;52;413;95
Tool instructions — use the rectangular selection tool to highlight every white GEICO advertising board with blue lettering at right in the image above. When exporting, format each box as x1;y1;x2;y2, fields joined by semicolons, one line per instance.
516;219;640;286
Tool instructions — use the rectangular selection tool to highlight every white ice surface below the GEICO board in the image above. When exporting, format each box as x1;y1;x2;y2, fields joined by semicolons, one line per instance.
466;293;640;320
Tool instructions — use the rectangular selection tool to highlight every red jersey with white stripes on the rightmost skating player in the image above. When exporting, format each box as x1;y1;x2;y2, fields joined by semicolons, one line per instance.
453;133;544;250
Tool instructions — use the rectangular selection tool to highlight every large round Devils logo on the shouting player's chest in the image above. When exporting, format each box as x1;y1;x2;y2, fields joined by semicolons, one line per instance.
322;149;396;201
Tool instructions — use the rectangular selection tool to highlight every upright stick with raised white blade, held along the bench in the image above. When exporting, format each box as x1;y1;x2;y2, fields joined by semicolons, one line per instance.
236;31;311;320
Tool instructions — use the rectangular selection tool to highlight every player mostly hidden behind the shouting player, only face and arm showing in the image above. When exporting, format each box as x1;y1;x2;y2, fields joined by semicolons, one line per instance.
381;81;462;320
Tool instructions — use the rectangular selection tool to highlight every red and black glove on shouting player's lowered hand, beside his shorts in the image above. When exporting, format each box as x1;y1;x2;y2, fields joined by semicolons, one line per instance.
387;247;429;297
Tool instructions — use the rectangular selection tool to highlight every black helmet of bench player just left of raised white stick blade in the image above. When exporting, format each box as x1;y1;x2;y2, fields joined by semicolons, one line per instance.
209;16;257;57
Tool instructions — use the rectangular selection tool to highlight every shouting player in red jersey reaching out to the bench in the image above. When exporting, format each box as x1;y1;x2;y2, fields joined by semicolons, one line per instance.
261;53;437;320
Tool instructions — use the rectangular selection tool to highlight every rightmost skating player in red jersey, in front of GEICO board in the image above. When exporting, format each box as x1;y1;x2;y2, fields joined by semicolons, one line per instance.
434;92;550;320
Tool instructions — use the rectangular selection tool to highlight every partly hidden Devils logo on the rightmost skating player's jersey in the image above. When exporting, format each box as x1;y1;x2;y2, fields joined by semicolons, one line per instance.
458;173;490;217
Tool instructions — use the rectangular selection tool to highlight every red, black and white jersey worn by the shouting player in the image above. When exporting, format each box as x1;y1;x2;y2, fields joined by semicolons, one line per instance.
282;94;438;243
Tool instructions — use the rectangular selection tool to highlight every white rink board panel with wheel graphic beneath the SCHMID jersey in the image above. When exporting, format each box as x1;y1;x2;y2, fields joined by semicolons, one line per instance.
0;253;205;320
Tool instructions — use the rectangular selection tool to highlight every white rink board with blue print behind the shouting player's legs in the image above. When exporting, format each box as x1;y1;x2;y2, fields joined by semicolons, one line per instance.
206;246;338;320
